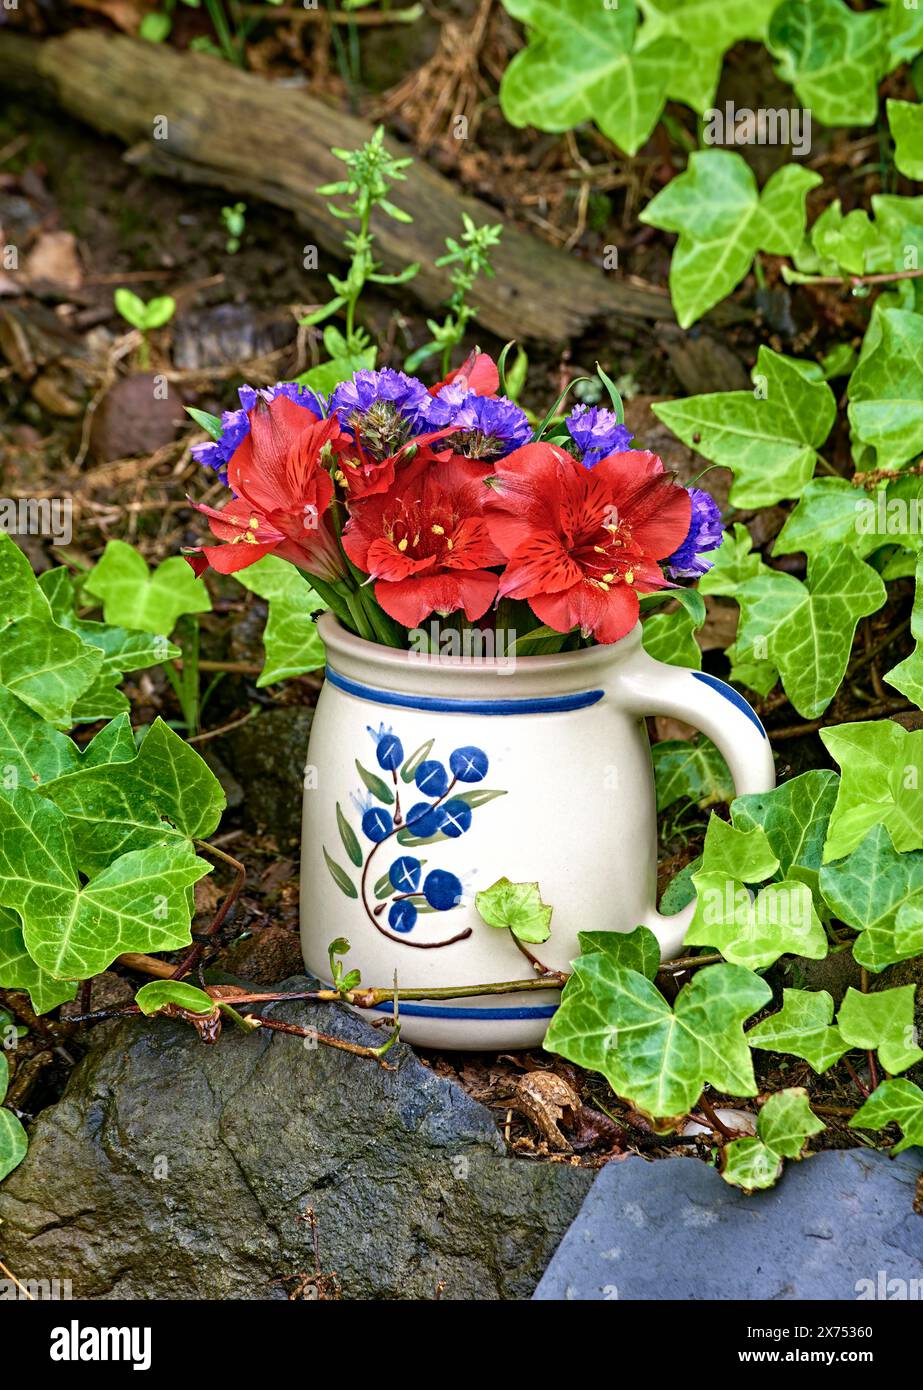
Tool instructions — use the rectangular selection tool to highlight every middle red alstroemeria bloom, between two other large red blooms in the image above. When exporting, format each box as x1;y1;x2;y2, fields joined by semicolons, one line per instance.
343;456;503;627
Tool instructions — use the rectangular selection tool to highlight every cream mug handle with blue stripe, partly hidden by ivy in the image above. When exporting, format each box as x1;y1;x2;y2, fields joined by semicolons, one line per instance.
617;645;776;960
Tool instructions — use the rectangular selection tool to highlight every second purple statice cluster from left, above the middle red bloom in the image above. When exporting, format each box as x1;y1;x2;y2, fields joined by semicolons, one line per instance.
329;367;434;459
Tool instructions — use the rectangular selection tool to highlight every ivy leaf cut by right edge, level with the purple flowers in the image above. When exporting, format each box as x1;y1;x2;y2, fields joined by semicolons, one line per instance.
848;309;923;468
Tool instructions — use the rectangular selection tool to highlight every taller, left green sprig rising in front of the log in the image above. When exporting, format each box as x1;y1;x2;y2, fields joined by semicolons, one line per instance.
303;125;420;353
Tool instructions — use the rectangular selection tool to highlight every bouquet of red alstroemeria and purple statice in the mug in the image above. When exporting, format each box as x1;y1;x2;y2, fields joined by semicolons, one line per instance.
189;350;721;644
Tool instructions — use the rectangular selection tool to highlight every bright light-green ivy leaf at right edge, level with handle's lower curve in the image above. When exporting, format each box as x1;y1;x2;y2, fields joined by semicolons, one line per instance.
820;719;923;863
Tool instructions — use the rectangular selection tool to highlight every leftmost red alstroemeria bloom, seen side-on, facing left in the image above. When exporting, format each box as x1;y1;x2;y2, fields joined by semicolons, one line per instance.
188;396;345;580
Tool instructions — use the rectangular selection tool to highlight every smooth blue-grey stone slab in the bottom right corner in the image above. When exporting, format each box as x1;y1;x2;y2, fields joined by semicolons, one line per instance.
532;1148;923;1301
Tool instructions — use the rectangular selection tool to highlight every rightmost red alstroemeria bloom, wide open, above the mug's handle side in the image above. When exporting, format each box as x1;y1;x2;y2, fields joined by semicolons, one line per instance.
485;443;691;642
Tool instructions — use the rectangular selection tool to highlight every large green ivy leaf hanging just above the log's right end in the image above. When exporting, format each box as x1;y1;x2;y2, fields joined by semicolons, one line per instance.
639;153;822;328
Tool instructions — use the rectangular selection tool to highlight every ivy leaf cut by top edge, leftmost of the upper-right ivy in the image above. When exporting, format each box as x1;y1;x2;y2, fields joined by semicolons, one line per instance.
500;0;676;154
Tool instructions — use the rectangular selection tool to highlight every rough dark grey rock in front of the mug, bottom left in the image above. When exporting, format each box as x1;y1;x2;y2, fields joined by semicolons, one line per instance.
0;979;592;1300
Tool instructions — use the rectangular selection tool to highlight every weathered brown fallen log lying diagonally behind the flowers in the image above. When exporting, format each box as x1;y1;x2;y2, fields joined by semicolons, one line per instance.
0;29;737;342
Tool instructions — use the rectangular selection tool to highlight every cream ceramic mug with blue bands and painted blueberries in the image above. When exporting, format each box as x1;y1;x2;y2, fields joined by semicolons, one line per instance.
302;613;774;1049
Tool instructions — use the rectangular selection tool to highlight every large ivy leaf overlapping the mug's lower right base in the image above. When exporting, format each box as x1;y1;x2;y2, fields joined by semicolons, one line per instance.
544;954;771;1131
